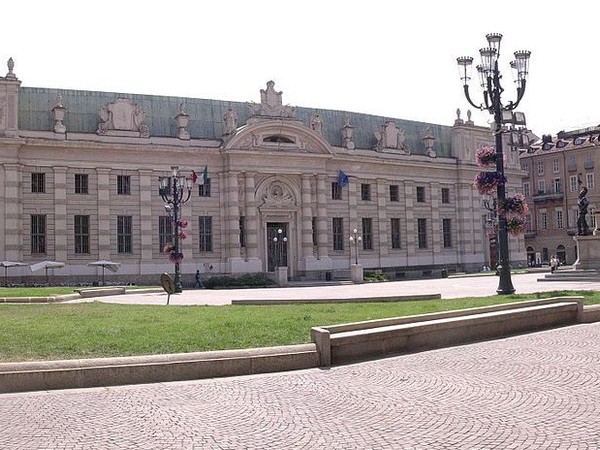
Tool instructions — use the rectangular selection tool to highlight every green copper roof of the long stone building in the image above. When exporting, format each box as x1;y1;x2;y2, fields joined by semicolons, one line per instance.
19;87;452;156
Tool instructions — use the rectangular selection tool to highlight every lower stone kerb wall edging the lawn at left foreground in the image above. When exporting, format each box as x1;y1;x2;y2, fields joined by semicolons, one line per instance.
0;344;319;393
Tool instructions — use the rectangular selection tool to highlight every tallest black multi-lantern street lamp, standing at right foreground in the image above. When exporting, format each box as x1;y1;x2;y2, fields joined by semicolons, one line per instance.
457;33;531;294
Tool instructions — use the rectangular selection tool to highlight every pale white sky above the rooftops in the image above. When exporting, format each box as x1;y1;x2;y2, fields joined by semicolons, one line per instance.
0;0;600;136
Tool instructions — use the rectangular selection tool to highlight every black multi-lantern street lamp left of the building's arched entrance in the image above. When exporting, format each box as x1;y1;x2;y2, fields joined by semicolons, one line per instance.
158;166;192;292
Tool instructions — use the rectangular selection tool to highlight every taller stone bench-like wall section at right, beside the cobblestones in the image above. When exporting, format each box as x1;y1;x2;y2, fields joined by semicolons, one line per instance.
311;297;583;366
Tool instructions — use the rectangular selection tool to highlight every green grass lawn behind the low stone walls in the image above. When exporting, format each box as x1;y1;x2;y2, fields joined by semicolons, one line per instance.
0;291;600;362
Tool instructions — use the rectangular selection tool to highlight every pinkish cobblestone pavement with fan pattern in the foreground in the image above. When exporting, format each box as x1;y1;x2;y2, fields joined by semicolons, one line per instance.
0;323;600;450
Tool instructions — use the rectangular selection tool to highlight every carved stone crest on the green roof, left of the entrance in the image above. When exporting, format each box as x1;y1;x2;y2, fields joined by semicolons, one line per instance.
96;97;150;138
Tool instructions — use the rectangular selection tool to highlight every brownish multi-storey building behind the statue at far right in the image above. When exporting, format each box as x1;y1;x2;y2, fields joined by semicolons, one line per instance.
521;127;600;265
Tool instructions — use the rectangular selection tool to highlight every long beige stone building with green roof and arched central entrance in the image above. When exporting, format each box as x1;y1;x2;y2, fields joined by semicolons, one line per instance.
0;60;525;284
